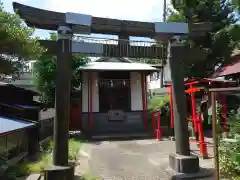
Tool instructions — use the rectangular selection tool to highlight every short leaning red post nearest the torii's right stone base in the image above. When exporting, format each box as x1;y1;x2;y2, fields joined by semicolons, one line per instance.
197;116;208;158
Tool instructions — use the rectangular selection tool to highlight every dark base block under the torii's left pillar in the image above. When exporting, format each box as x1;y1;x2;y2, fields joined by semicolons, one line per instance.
44;165;74;180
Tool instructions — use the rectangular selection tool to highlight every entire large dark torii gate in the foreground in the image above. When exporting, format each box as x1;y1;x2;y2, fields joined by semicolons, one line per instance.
13;2;211;180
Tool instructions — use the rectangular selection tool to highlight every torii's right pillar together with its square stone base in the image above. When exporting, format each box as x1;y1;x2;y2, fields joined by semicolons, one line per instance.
169;42;199;173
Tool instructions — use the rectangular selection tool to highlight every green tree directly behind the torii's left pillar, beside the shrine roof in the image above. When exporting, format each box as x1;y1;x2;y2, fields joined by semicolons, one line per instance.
34;33;90;107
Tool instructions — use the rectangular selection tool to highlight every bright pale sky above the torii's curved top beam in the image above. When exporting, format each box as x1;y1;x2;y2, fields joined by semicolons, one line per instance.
2;0;170;38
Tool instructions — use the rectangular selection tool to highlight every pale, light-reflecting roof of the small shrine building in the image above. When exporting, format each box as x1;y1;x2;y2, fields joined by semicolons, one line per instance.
79;62;159;71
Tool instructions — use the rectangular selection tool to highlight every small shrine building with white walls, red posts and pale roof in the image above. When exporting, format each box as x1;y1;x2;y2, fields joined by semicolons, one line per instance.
80;58;159;133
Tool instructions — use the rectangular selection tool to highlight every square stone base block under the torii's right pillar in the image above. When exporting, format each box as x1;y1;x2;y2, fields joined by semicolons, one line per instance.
169;154;200;173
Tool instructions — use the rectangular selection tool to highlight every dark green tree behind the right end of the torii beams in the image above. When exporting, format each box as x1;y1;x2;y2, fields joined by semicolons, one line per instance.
168;0;240;77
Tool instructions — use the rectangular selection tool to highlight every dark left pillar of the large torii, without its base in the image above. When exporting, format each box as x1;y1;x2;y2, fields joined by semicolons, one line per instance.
53;26;73;166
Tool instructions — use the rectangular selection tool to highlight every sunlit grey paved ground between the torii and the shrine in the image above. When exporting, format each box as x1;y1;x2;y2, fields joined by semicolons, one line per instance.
76;139;216;180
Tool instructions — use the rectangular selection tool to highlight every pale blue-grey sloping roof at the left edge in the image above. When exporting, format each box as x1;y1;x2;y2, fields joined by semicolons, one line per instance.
0;116;35;135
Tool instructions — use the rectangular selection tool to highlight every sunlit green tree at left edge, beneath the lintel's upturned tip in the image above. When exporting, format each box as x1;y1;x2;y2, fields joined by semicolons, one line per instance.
0;0;43;77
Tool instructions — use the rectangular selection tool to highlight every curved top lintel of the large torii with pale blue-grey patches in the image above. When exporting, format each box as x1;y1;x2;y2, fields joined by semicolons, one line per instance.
13;2;211;39
